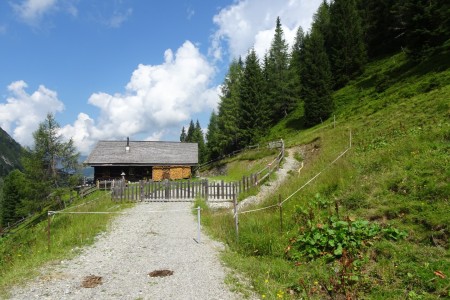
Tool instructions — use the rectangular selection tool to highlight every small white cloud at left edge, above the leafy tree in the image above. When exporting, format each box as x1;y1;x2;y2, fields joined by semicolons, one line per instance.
0;81;64;146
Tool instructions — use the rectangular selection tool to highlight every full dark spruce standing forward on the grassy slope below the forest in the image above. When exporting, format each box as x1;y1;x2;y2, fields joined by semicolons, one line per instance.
301;27;333;126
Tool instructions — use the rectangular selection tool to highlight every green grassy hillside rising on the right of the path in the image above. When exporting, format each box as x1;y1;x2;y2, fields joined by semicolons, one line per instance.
203;53;450;299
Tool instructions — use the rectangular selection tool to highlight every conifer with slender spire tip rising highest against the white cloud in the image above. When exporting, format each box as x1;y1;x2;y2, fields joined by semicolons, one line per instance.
265;17;296;123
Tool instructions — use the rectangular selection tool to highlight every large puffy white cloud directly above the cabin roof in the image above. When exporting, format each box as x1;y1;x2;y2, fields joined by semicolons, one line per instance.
62;41;218;153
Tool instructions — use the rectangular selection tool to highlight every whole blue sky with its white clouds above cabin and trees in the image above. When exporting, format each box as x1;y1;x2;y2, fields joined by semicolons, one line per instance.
0;0;321;154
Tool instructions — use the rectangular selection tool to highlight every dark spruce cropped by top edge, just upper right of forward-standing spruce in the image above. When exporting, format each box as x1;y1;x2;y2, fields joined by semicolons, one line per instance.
329;0;366;88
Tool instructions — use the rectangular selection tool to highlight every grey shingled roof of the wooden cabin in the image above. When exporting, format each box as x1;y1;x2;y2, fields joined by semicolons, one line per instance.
84;141;198;166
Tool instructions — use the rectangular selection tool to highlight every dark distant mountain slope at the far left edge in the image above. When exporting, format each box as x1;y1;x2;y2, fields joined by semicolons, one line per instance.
0;127;23;177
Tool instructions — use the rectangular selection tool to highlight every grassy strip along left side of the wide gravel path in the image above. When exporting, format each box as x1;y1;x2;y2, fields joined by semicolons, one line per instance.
0;191;131;297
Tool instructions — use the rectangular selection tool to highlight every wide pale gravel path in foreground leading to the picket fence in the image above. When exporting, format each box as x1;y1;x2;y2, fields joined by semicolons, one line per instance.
11;202;242;299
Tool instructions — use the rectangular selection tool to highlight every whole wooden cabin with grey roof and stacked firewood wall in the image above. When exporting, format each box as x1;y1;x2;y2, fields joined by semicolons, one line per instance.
84;139;198;181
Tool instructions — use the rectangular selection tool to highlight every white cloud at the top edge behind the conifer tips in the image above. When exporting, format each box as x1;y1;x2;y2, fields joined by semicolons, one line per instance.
209;0;322;60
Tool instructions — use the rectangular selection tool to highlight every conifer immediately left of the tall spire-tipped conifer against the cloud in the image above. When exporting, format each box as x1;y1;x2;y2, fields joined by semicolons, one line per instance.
238;49;269;147
